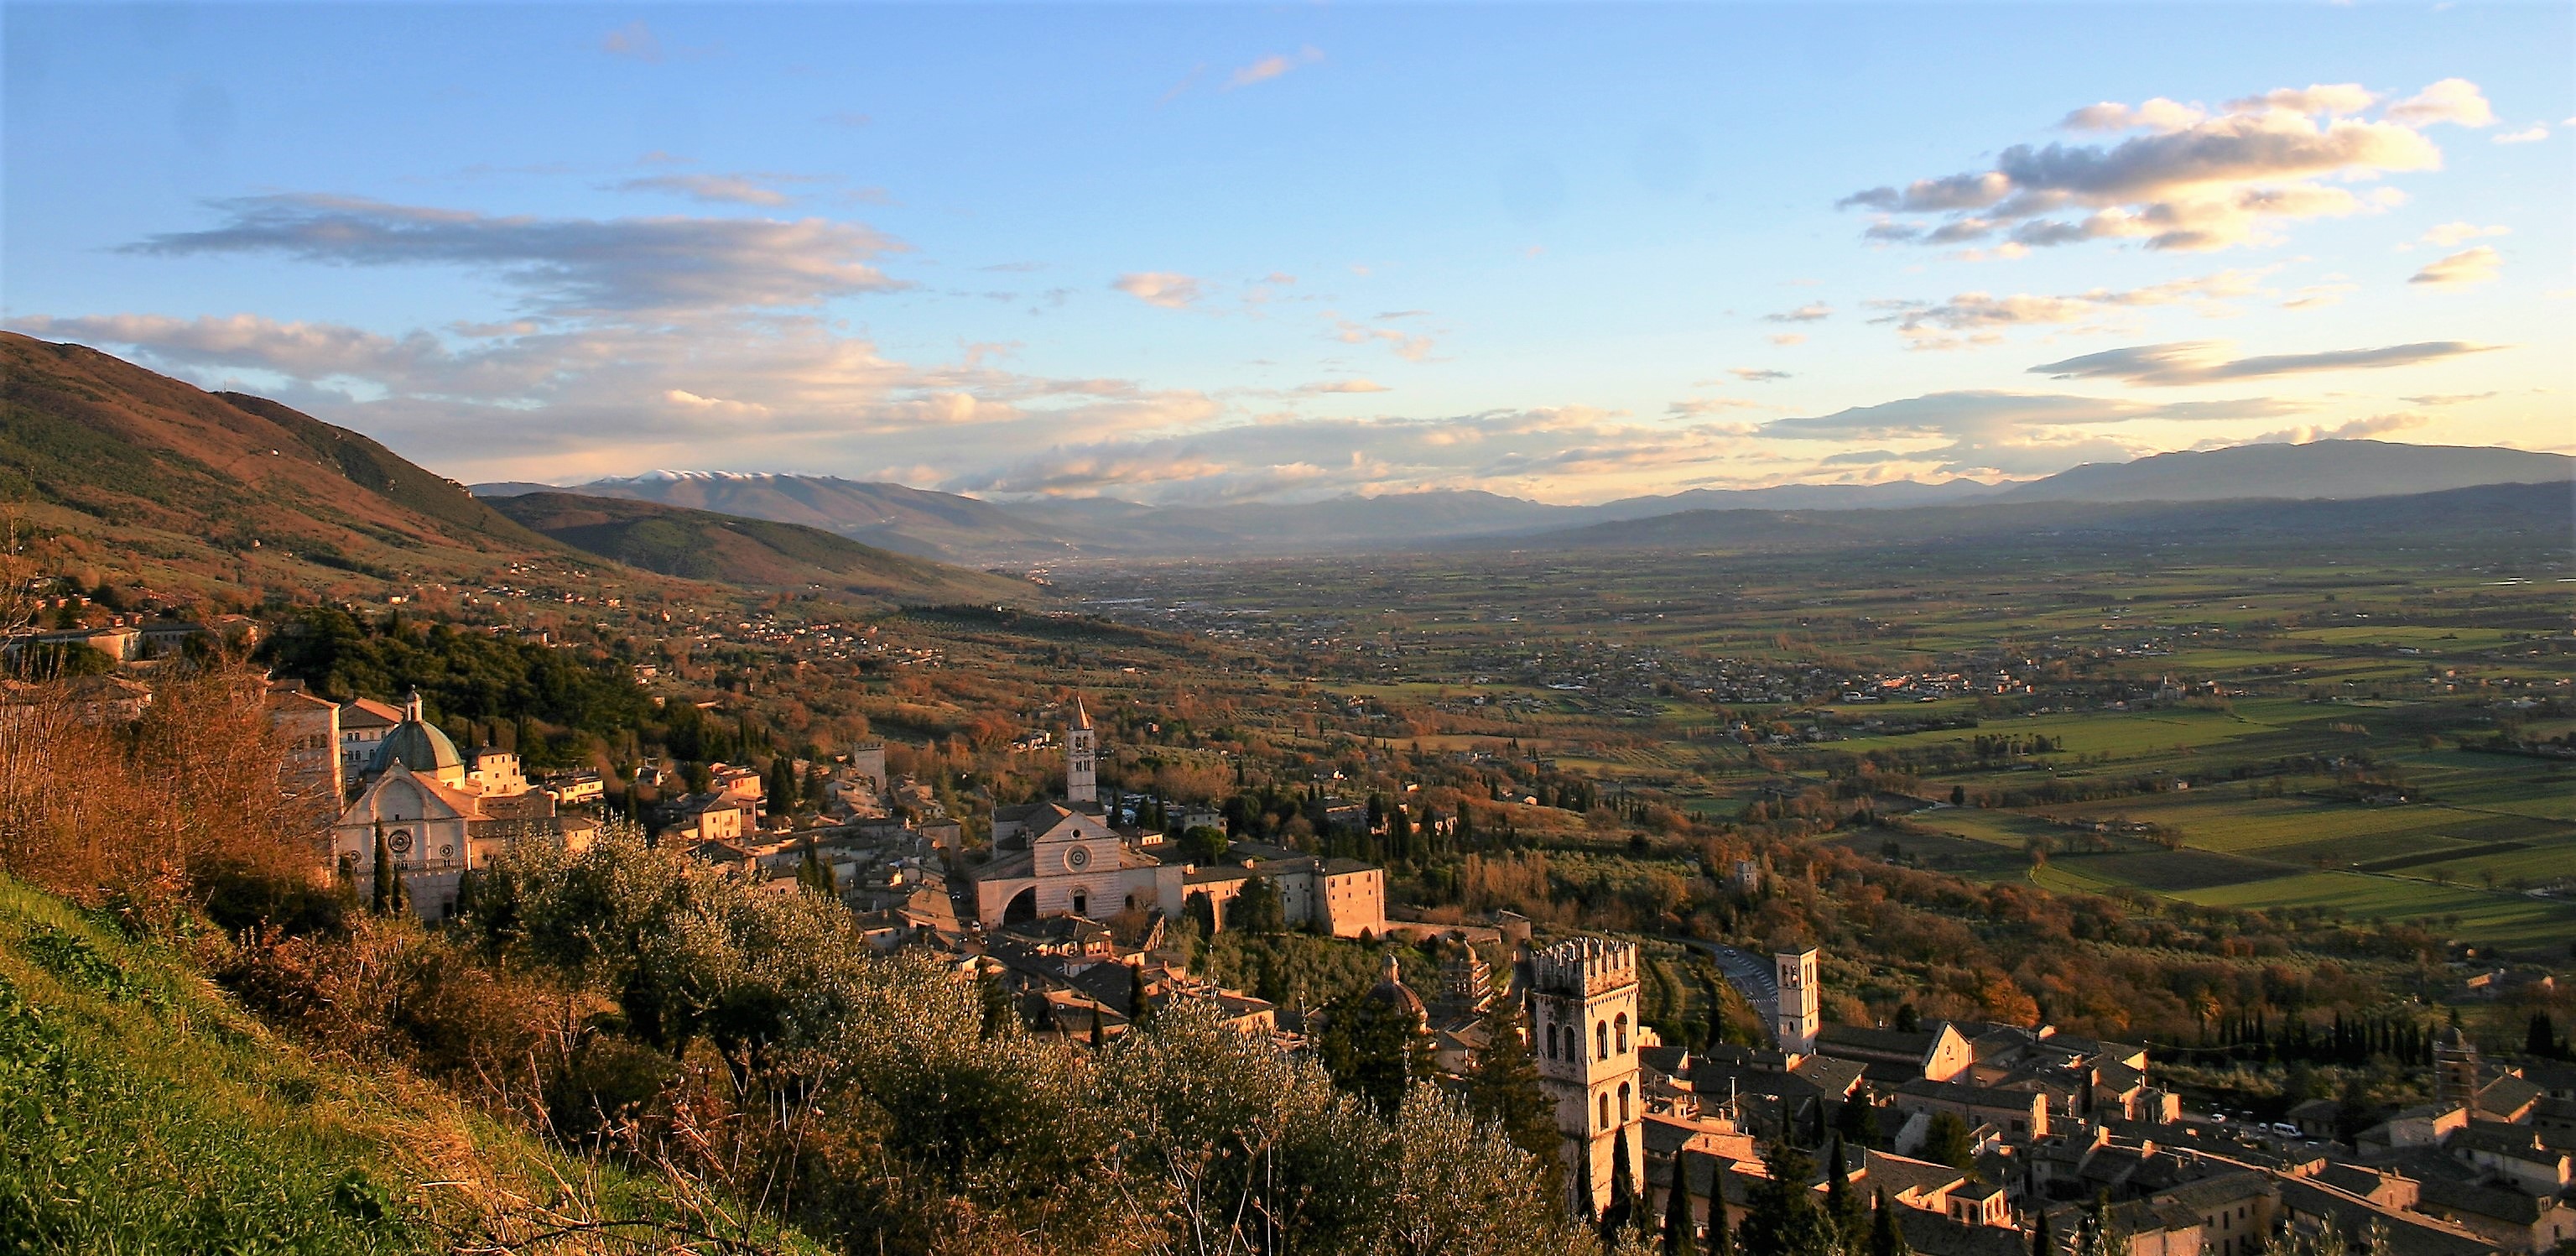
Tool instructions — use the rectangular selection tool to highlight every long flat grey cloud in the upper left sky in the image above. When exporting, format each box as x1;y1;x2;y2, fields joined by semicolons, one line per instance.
123;196;907;315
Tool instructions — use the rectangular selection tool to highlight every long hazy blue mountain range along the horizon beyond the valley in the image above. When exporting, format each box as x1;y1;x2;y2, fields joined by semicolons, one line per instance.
474;441;2576;562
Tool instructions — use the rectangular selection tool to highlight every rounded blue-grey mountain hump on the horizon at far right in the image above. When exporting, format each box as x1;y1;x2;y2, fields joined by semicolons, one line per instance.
1994;441;2576;503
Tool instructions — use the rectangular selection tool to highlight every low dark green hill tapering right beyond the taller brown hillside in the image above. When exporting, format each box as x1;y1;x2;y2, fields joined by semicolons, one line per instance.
492;492;1036;603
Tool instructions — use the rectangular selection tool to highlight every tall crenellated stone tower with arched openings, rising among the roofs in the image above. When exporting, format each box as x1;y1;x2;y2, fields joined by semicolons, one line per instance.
1525;939;1646;1215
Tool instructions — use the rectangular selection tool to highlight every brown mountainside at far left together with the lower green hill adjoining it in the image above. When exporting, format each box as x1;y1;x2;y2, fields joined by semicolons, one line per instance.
0;333;1043;603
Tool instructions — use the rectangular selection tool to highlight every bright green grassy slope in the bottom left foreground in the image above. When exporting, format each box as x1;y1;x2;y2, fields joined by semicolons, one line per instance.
0;879;819;1253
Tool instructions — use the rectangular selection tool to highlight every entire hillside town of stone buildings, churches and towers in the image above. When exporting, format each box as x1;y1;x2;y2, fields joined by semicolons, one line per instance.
23;603;2576;1256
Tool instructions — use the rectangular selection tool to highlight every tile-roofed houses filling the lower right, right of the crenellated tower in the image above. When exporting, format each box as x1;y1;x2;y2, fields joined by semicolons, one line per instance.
1595;951;2576;1256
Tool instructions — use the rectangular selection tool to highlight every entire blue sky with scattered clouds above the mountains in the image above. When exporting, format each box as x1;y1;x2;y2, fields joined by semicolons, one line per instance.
0;0;2576;503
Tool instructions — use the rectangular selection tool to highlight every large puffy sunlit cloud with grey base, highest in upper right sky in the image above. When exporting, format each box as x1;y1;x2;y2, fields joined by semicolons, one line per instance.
1840;80;2486;255
